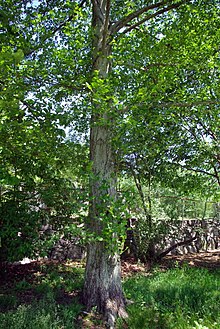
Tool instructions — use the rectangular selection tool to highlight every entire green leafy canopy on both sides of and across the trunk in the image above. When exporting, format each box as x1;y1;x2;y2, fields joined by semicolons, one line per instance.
0;0;219;298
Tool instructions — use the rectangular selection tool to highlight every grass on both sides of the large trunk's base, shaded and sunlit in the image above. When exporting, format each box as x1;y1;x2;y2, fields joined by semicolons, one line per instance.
0;264;220;329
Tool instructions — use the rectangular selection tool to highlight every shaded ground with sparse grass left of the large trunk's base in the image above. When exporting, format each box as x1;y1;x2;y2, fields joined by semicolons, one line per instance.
0;262;83;329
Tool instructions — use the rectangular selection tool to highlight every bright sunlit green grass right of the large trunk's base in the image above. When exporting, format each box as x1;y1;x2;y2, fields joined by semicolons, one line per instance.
118;267;220;329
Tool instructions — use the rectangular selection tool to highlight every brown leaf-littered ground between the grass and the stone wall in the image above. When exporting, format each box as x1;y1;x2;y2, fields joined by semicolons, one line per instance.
0;250;220;329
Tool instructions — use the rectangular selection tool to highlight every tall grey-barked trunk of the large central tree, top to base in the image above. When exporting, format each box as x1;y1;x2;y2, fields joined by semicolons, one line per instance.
83;0;126;328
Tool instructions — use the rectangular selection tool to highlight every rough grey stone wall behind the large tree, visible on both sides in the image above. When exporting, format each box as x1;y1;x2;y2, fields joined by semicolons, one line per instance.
48;219;220;261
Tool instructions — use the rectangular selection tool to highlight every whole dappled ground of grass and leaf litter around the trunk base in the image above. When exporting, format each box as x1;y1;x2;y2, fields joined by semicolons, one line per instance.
0;252;220;329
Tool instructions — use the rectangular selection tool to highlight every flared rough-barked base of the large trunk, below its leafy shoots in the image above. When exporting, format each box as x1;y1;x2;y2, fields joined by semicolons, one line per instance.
83;242;128;329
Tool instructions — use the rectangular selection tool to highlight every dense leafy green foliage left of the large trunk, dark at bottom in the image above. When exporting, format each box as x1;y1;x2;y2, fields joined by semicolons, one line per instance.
0;1;88;260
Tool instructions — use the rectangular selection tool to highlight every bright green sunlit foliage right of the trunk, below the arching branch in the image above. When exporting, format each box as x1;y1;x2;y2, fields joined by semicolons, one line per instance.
113;2;219;193
